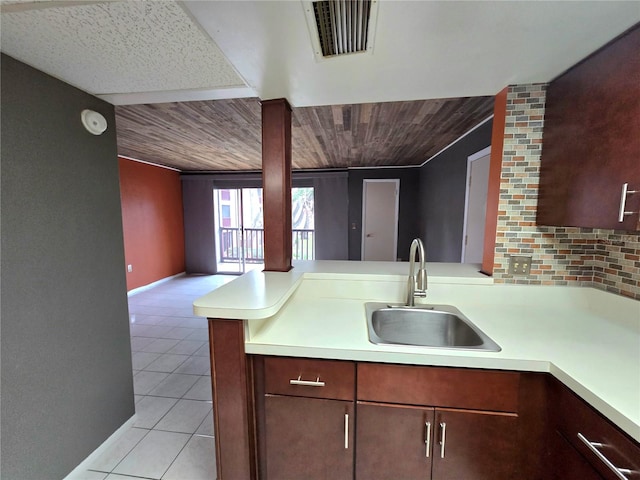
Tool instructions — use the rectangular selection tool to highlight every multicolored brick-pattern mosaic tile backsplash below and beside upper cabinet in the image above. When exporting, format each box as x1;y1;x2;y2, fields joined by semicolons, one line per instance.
493;84;640;300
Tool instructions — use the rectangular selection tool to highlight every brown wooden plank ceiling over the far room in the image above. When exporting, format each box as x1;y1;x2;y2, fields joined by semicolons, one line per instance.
116;97;493;171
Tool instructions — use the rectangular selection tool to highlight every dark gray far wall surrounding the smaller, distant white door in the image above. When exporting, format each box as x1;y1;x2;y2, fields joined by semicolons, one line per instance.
348;167;420;261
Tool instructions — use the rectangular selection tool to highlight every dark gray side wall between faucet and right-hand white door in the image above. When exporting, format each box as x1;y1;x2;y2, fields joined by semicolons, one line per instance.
419;120;493;262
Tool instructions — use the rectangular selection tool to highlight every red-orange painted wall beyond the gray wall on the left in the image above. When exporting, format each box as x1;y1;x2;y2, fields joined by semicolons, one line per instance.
118;158;185;290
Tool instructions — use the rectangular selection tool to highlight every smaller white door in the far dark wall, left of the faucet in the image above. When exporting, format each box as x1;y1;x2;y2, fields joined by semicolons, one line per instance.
361;179;400;261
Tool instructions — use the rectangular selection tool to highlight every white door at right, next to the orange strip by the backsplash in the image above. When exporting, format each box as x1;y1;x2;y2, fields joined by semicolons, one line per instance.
462;147;491;263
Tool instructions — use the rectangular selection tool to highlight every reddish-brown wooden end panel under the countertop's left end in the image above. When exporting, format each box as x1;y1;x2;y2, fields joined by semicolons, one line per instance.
209;318;257;480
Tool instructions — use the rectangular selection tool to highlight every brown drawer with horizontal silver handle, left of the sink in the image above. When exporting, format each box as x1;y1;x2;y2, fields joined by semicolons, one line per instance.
264;357;356;400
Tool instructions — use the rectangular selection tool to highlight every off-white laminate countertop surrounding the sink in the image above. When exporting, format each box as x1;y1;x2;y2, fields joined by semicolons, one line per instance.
194;261;640;442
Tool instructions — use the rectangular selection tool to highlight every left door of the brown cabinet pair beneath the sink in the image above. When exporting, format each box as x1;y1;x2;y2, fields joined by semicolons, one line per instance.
356;403;434;480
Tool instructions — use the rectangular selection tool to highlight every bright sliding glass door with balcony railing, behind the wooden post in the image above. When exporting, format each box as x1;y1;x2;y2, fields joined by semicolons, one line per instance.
214;187;315;273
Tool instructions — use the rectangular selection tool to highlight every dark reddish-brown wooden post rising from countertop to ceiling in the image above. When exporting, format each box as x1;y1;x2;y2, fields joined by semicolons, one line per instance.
262;98;292;272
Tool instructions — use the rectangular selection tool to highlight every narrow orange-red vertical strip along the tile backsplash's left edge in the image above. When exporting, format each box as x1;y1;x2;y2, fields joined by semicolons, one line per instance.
481;87;509;275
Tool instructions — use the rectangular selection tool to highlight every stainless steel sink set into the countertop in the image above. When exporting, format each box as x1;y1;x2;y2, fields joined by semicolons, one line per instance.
365;302;501;352
